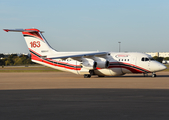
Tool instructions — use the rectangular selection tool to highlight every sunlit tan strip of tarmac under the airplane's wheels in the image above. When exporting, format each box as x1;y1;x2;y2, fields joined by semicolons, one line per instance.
0;72;169;90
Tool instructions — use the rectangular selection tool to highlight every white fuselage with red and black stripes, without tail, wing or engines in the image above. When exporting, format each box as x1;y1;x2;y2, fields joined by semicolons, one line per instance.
33;52;166;76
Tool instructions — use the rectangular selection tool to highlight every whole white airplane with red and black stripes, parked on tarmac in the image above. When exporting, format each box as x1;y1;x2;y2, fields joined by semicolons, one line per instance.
4;28;166;78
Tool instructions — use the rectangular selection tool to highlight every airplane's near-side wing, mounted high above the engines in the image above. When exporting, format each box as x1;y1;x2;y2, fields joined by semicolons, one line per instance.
49;52;109;61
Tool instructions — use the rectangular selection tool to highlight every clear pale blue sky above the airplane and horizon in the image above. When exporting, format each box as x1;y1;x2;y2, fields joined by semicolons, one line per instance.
0;0;169;53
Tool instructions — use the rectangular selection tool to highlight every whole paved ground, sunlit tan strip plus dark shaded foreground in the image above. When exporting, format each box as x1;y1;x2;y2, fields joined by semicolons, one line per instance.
0;72;169;120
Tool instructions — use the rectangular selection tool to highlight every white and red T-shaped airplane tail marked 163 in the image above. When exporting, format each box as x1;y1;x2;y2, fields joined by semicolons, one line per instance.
4;28;57;56
